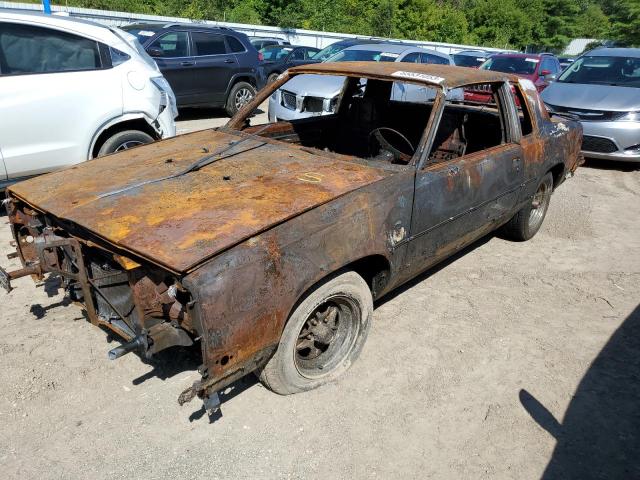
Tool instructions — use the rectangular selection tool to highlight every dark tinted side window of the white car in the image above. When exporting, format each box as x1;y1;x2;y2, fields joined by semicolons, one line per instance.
0;24;103;75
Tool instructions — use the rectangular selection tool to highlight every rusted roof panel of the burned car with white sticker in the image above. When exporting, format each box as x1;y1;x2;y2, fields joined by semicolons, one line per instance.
289;62;518;89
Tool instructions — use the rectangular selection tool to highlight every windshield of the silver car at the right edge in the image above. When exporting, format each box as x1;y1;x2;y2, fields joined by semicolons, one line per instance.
558;56;640;88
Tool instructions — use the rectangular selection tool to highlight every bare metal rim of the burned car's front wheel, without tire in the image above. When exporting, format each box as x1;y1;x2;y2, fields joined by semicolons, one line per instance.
294;295;362;378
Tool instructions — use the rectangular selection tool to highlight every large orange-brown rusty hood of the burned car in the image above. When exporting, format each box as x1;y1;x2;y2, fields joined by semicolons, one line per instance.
9;130;386;272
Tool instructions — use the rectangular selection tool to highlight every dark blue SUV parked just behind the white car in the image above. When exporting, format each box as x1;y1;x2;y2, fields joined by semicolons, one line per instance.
122;23;266;115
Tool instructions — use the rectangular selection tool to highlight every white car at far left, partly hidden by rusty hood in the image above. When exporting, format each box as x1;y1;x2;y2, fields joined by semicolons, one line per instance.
0;12;177;187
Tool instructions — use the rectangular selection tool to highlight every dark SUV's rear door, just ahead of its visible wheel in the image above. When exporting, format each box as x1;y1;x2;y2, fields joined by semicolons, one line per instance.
191;31;238;104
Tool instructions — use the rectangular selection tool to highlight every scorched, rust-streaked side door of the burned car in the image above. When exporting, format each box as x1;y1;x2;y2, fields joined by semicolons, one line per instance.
407;84;523;273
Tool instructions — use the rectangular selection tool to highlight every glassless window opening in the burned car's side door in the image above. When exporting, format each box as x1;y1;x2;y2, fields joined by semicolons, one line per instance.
429;83;505;163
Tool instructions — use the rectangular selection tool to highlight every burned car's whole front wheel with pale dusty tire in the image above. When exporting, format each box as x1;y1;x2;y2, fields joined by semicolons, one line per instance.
259;272;373;395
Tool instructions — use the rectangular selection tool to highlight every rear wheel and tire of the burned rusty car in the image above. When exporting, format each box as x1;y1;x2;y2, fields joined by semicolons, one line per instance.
502;173;553;242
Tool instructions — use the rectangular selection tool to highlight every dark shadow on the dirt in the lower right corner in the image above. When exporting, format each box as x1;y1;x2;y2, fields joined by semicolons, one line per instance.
520;305;640;480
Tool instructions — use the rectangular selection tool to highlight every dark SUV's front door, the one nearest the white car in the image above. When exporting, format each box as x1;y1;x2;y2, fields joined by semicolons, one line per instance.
146;30;196;106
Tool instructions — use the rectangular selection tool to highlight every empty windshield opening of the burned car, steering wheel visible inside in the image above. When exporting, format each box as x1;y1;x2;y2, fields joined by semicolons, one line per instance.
228;72;440;170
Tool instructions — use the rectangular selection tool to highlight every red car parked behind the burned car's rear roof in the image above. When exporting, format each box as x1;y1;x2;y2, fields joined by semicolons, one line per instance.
464;53;562;103
